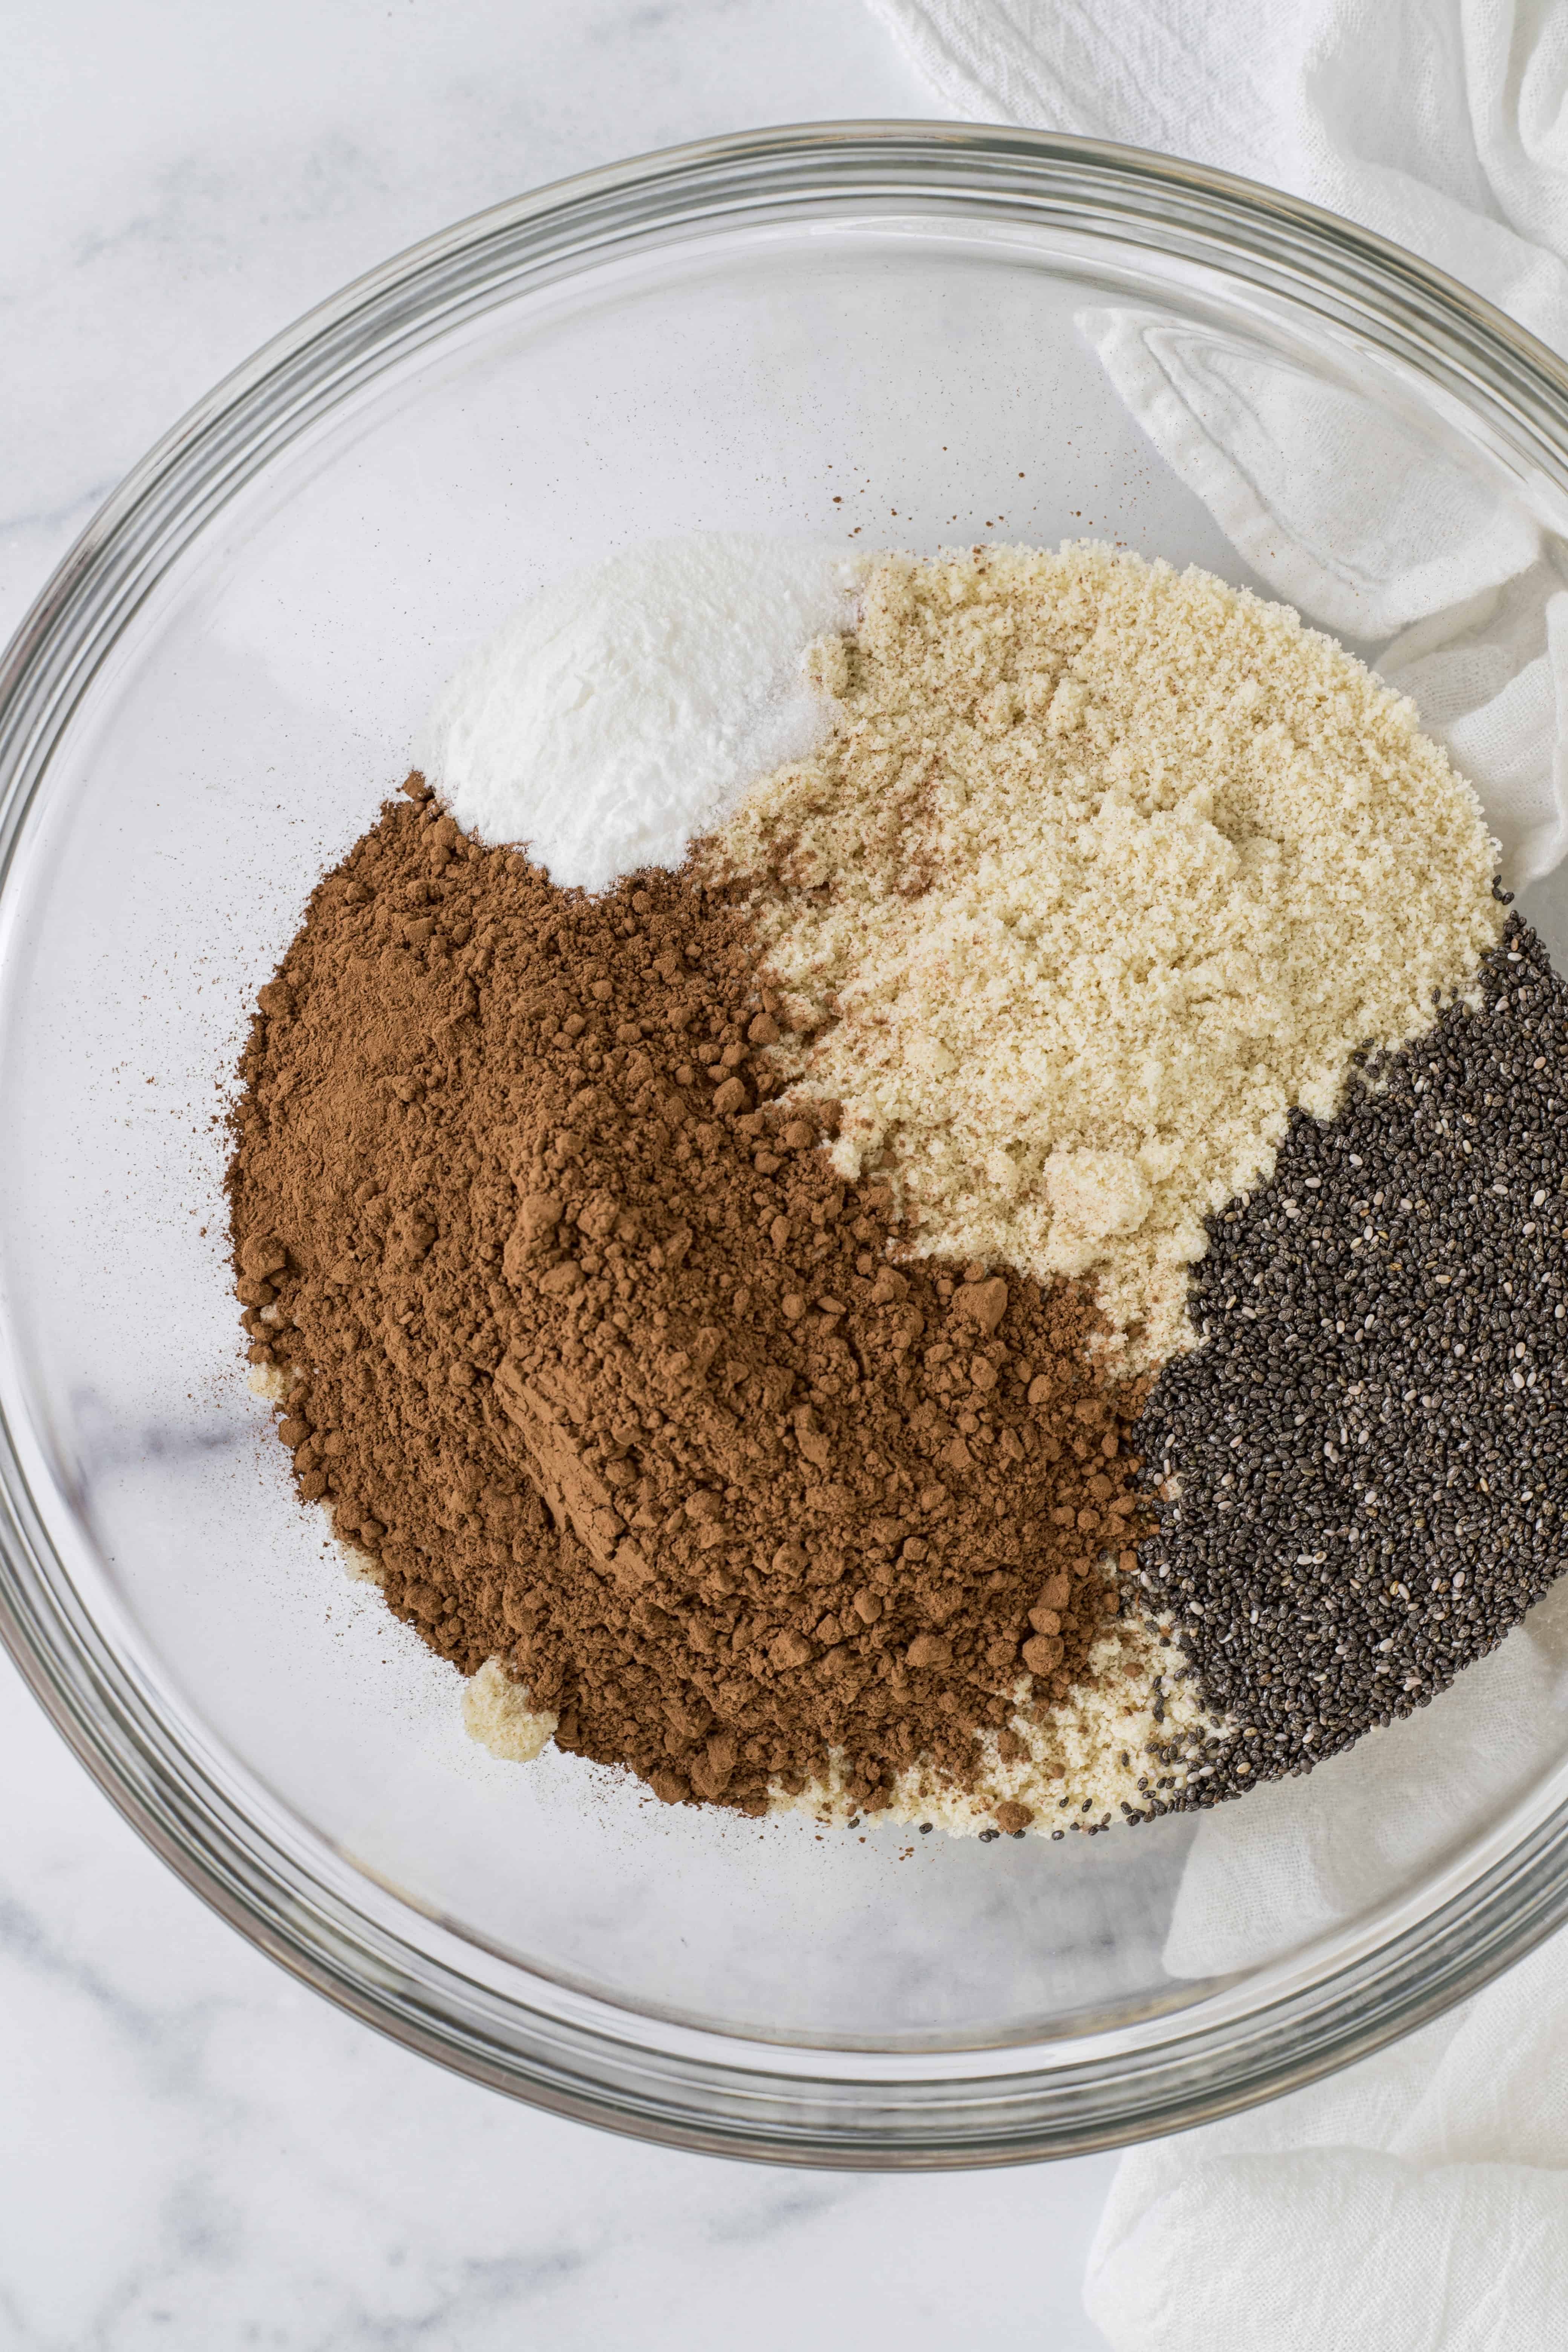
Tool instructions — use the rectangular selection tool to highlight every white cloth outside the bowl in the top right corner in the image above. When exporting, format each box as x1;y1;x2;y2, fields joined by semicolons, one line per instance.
870;0;1568;353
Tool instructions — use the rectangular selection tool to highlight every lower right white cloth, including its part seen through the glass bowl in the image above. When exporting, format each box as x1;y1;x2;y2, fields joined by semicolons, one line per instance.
1084;1585;1568;2352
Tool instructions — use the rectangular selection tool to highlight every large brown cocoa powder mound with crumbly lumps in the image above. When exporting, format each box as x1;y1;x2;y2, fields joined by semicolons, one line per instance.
230;778;1142;1813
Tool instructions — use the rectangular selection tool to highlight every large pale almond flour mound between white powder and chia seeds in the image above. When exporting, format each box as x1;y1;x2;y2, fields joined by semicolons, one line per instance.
703;543;1502;1371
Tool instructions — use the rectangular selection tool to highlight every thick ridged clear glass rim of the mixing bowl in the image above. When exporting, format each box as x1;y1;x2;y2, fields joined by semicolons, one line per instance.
0;122;1568;2168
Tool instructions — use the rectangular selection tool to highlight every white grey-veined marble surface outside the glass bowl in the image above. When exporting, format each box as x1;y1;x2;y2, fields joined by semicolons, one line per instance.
0;0;1114;2352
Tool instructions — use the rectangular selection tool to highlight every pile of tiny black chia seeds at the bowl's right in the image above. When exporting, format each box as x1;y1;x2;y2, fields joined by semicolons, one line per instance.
1140;915;1568;1811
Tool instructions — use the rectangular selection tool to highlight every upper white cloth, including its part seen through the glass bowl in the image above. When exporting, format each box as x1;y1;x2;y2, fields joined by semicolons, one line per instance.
870;0;1568;887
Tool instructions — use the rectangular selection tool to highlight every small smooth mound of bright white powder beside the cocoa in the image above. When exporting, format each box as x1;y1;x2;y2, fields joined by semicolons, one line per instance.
414;531;863;891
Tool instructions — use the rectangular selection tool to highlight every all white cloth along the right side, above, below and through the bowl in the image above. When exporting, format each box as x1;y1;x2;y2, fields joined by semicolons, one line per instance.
870;0;1568;2352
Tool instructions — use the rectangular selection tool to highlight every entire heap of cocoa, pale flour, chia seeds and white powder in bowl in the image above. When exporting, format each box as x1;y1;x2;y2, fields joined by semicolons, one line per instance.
230;548;1568;1839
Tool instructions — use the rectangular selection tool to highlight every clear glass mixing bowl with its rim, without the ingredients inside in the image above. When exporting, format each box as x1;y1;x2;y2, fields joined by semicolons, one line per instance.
0;122;1568;2166
